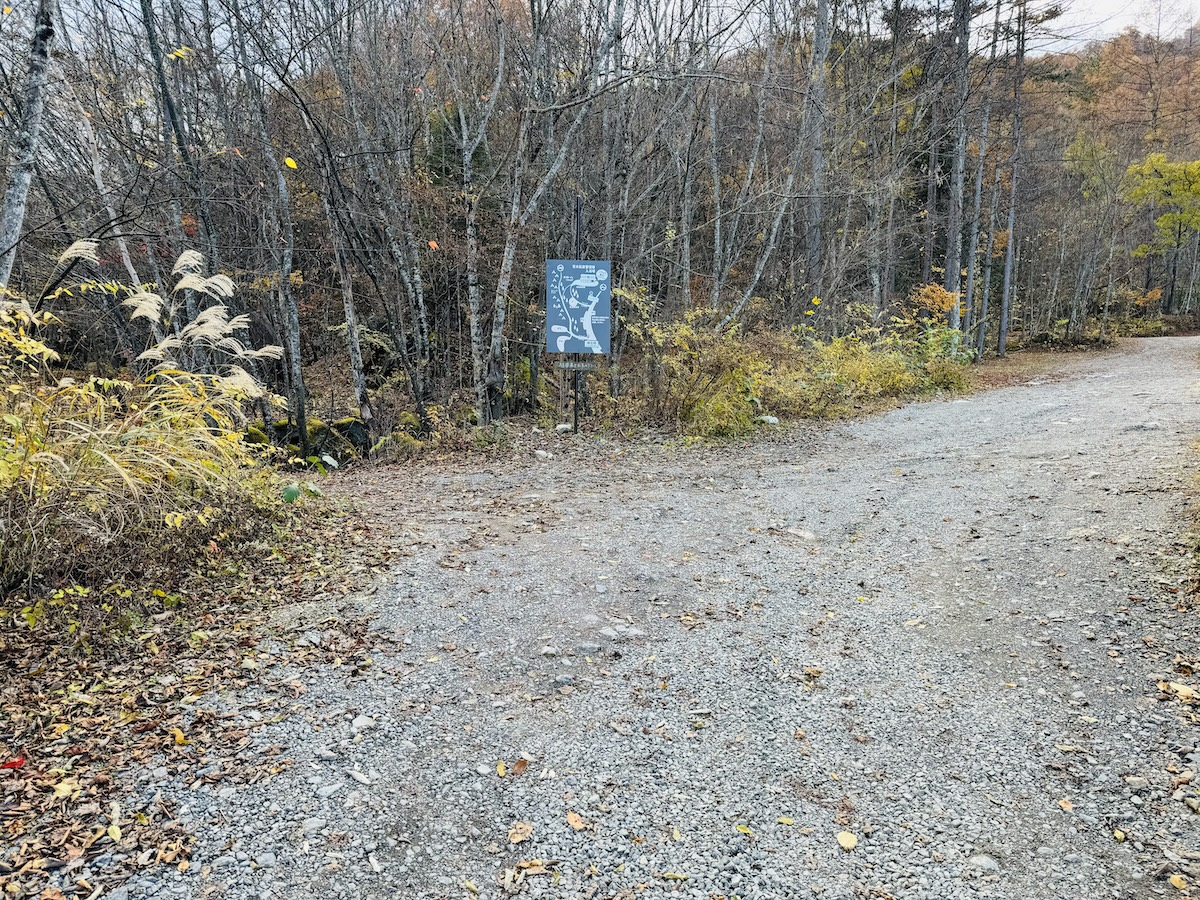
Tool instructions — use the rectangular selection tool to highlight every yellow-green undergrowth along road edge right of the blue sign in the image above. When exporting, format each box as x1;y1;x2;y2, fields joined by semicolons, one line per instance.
601;287;970;438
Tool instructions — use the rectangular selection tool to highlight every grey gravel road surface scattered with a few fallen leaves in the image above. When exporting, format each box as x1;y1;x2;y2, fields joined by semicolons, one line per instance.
108;338;1200;900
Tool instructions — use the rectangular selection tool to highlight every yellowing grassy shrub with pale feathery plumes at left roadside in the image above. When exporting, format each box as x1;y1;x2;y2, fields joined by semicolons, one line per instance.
0;250;282;602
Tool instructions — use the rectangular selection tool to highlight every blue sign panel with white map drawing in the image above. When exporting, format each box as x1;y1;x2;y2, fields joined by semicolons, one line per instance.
546;259;612;353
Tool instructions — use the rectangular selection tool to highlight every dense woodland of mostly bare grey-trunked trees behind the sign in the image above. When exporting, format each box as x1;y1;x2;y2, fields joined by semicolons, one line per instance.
0;0;1200;443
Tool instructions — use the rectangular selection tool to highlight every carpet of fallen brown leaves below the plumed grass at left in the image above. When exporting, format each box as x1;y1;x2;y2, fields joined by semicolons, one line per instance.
0;511;395;900
